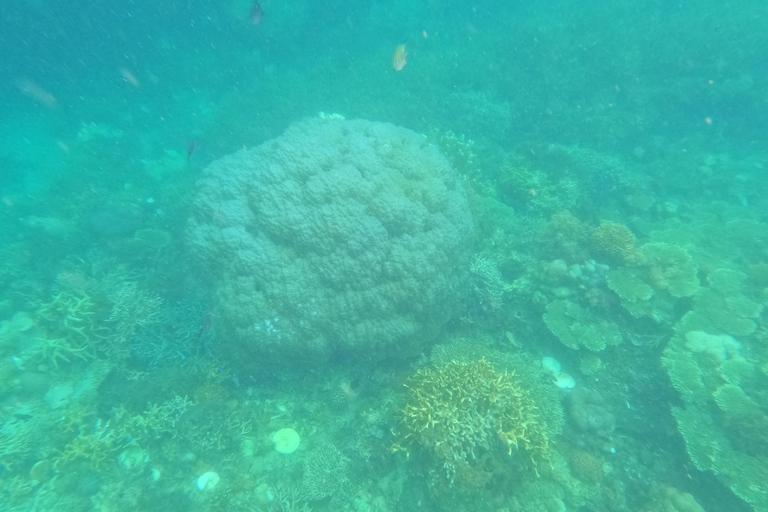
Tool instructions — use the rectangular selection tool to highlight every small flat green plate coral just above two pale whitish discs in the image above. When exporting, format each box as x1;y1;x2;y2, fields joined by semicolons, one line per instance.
544;300;622;352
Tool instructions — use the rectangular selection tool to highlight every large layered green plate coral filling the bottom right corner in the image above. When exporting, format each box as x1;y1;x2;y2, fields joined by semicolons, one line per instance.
662;326;768;510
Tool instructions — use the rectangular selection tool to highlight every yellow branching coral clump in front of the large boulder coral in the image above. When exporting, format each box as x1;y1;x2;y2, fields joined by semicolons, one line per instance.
394;359;549;479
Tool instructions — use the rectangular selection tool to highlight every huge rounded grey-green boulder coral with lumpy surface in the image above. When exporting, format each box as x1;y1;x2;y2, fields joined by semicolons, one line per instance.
188;119;474;360
